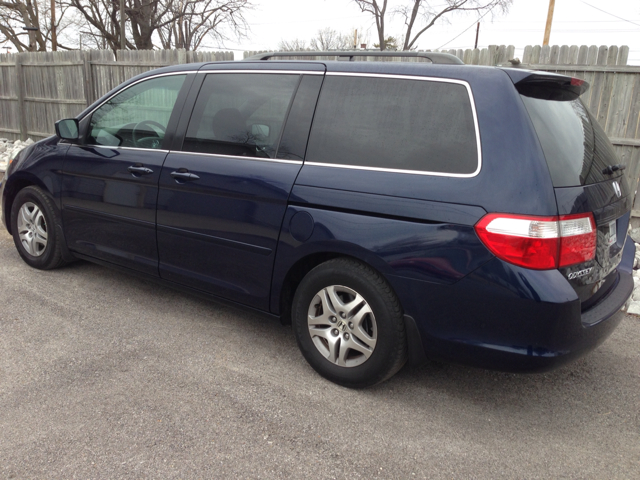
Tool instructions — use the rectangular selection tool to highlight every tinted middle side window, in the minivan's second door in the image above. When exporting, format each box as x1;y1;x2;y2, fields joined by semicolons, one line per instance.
182;73;300;158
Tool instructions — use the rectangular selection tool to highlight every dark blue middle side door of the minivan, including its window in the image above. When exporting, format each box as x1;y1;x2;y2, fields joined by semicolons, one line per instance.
157;66;324;310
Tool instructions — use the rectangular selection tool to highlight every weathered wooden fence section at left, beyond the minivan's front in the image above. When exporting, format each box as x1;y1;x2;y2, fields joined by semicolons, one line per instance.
0;50;233;140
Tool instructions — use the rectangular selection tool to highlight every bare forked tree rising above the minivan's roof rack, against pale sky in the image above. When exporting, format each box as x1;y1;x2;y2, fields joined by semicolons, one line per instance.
353;0;513;50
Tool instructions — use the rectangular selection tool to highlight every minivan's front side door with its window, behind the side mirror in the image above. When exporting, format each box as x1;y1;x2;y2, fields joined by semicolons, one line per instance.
62;74;187;276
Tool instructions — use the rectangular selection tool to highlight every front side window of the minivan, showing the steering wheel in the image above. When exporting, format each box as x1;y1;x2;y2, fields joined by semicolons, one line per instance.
87;75;186;148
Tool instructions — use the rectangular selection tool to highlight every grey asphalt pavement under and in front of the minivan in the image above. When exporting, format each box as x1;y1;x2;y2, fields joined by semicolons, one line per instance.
0;230;640;479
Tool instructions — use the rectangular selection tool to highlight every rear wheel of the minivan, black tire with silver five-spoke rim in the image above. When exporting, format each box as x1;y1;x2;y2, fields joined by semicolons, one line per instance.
292;258;407;388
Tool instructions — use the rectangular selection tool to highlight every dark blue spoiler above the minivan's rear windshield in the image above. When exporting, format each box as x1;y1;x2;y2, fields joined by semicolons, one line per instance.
504;68;589;102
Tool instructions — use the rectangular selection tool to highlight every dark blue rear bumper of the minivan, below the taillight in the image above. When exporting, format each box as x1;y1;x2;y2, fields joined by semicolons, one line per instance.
392;239;635;372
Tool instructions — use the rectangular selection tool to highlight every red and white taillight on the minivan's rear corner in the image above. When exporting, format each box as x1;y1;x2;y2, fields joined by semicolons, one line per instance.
475;213;597;270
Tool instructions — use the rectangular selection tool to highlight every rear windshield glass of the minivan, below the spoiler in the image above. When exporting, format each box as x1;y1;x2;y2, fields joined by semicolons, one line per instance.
521;95;622;187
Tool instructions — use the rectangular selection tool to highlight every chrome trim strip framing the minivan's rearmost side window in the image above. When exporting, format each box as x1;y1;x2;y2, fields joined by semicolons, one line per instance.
314;72;482;178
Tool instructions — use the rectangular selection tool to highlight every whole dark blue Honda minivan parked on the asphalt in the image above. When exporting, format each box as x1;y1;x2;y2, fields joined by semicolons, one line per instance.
0;52;635;387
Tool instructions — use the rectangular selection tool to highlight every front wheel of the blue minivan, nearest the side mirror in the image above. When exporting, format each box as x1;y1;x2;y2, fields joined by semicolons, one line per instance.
11;186;67;270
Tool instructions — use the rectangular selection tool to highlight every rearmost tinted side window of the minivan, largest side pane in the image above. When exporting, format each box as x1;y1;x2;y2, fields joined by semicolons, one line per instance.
306;76;479;175
